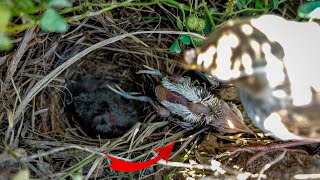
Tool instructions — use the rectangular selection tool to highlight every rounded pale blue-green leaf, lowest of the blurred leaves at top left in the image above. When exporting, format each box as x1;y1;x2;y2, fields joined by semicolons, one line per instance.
40;8;69;33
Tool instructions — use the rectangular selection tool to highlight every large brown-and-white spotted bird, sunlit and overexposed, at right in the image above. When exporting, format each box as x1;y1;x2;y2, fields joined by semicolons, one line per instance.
185;15;320;141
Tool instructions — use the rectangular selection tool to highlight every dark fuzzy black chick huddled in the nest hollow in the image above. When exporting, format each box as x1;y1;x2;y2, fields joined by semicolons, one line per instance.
66;77;138;138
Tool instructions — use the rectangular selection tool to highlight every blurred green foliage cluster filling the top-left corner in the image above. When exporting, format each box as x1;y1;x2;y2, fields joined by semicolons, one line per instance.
0;0;71;50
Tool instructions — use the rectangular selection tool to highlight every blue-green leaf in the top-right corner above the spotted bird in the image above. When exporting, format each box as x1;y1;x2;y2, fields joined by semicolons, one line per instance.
298;1;320;19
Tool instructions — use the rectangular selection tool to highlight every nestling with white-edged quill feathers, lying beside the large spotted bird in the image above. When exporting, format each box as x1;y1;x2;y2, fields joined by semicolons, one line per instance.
113;66;252;133
